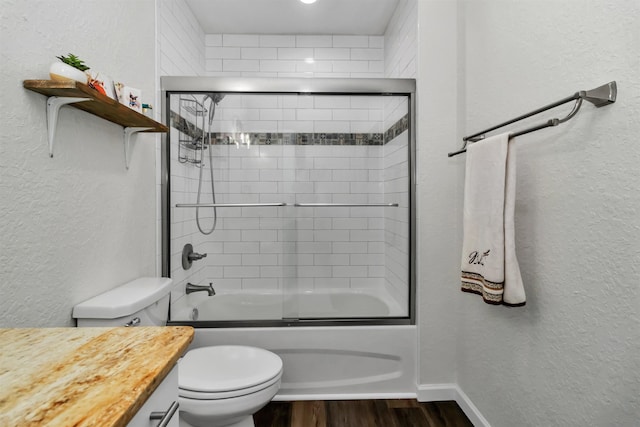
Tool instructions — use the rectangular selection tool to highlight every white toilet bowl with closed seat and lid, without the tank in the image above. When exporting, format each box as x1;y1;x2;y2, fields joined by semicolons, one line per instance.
178;345;282;427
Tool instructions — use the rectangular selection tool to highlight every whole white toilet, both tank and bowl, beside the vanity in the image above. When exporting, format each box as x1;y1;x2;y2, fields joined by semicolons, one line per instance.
73;277;282;427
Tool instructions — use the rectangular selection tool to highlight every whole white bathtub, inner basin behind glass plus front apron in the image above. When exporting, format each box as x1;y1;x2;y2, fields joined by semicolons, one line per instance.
171;290;417;400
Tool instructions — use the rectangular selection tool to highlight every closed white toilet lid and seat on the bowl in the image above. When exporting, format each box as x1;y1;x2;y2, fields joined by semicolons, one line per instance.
179;345;282;400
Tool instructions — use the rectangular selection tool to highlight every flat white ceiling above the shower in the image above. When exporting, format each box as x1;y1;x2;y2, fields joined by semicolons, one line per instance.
186;0;398;35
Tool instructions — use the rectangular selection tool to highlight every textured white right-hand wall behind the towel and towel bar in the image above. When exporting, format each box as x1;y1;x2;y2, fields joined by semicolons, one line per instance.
456;0;640;427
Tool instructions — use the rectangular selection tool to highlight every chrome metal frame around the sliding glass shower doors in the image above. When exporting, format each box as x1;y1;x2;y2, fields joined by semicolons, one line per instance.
160;76;417;327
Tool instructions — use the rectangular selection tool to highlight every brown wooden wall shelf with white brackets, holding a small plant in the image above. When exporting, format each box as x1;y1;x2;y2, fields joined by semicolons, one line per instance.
23;80;169;169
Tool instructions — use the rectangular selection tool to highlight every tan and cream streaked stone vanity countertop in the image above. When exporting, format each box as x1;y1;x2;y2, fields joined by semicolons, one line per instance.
0;326;194;427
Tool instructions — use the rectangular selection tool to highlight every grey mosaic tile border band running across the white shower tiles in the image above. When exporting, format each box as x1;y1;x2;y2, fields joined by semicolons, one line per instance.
171;111;409;145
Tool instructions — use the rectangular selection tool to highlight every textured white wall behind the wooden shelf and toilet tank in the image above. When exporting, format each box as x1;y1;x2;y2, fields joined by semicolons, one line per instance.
0;0;157;327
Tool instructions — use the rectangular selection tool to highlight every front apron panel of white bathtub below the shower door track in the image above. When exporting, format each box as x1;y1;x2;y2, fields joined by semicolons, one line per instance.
190;325;417;400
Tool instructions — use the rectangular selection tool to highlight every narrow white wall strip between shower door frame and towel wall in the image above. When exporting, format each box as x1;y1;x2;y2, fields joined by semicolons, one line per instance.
416;0;464;385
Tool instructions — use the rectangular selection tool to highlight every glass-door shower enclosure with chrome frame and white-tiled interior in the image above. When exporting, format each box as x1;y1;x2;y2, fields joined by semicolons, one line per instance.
162;77;415;327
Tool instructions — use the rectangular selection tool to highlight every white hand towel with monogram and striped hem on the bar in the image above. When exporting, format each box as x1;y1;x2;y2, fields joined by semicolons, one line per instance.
461;133;526;306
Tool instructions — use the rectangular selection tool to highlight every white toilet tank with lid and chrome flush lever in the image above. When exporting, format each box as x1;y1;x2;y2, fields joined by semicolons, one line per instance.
72;277;173;327
